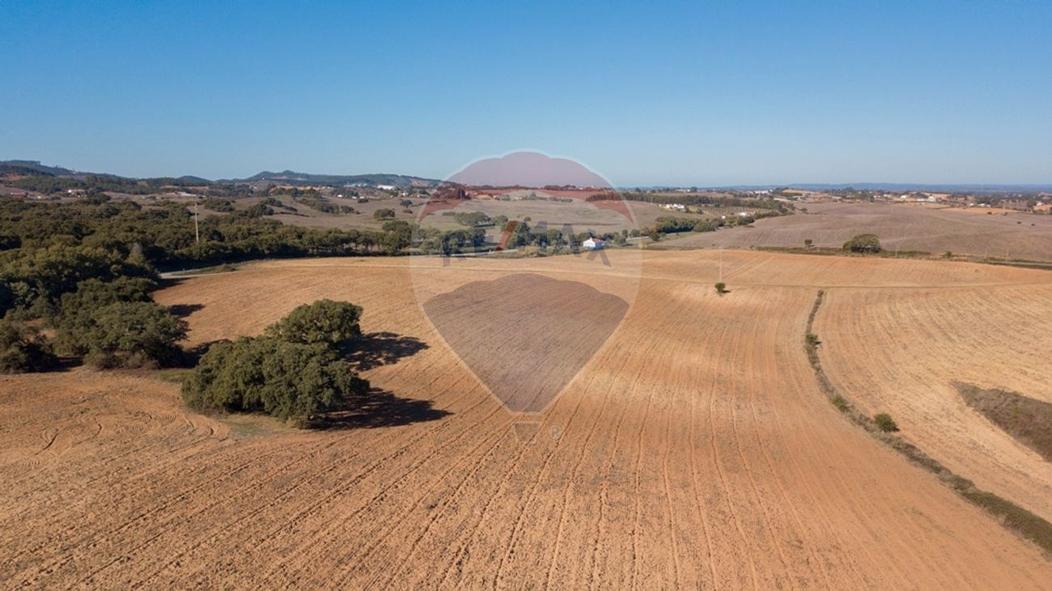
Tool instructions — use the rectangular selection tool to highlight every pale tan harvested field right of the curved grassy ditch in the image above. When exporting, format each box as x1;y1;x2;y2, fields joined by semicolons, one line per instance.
815;283;1052;521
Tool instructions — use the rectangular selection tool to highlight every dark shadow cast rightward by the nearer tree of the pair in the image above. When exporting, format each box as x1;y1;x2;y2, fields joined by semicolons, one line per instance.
308;388;452;430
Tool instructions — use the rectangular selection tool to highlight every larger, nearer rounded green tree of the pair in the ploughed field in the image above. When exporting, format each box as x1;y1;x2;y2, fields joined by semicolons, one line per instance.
183;337;368;421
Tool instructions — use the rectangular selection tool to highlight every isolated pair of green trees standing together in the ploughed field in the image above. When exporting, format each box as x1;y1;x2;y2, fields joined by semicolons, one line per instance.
183;300;369;423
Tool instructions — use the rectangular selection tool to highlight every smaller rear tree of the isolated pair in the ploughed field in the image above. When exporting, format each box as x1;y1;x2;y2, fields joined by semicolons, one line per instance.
266;300;362;347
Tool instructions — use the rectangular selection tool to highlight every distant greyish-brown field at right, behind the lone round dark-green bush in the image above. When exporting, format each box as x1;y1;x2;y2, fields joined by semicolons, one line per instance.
658;203;1052;261
